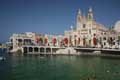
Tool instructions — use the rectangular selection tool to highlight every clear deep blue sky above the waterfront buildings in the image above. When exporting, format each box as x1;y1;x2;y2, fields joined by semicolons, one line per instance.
0;0;120;42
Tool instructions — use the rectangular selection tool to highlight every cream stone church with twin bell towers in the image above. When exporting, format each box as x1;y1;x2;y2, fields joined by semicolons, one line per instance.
64;7;109;47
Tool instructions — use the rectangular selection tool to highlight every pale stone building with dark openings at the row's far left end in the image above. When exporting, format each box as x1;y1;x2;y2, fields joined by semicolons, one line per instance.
9;32;35;51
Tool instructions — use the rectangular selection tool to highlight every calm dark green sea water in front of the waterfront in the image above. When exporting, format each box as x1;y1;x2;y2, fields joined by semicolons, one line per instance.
0;55;120;80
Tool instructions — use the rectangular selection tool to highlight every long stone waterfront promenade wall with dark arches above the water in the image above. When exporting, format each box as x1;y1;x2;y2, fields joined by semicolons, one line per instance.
22;46;120;55
